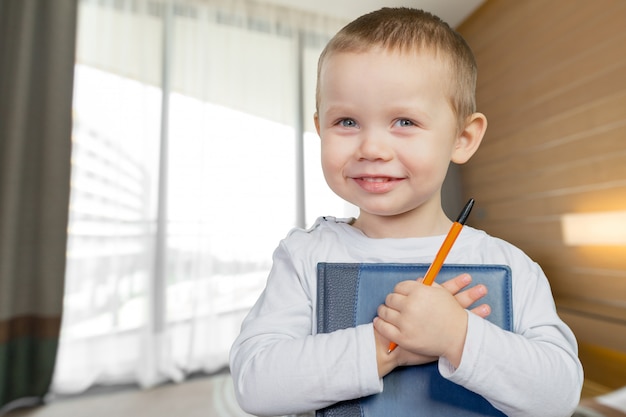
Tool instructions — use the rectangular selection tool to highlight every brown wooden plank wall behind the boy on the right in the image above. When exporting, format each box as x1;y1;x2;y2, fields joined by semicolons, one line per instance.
458;0;626;388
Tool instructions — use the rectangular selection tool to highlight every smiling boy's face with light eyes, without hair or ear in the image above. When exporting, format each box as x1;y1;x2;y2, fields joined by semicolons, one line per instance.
316;49;457;228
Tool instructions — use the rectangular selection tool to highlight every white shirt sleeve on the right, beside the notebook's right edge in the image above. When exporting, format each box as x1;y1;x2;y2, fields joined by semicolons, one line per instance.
439;258;583;417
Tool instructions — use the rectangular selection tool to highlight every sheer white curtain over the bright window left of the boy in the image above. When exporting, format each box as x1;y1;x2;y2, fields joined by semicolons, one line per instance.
52;0;347;393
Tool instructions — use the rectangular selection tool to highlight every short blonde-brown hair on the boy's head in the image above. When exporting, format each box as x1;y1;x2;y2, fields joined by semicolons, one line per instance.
315;7;477;127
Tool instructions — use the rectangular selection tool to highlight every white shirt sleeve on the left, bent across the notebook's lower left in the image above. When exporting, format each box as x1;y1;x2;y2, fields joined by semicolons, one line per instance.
230;239;382;415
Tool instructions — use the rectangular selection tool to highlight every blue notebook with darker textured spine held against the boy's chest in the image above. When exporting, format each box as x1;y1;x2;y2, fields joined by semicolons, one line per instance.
316;263;513;417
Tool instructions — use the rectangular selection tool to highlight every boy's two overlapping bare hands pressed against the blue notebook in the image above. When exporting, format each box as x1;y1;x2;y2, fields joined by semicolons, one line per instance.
374;274;491;377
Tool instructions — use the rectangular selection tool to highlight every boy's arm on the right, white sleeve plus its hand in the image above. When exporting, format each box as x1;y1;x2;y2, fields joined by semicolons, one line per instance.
375;262;582;417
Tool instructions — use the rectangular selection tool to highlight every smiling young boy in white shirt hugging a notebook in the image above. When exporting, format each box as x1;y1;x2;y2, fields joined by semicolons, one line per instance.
231;8;582;417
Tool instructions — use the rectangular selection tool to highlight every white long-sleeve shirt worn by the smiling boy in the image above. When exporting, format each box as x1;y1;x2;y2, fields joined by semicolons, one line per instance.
230;217;583;417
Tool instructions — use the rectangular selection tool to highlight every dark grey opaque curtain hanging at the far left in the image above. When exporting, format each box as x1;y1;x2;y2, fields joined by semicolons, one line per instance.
0;0;77;412
